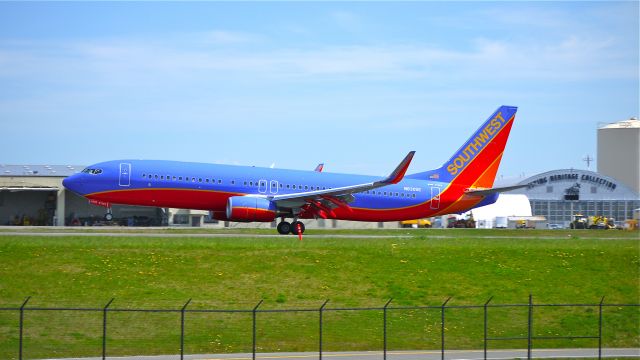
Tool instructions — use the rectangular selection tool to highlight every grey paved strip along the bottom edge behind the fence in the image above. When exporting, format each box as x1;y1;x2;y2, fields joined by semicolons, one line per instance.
46;348;640;360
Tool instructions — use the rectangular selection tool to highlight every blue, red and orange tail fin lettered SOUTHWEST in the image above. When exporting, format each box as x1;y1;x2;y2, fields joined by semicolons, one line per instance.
406;105;518;188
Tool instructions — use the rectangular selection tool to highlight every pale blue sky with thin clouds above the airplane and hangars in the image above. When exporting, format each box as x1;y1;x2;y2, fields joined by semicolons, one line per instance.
0;1;640;177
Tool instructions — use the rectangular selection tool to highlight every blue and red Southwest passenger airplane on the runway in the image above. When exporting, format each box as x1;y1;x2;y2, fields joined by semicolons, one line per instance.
63;106;522;236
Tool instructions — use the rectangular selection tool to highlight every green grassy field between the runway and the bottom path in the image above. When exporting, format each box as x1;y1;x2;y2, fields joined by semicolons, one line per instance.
0;229;640;359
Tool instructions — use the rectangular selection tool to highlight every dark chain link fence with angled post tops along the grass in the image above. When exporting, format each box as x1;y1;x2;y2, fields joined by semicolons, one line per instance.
0;296;640;360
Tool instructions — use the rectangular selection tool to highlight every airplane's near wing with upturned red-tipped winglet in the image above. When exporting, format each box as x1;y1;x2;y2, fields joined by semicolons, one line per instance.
255;151;415;210
